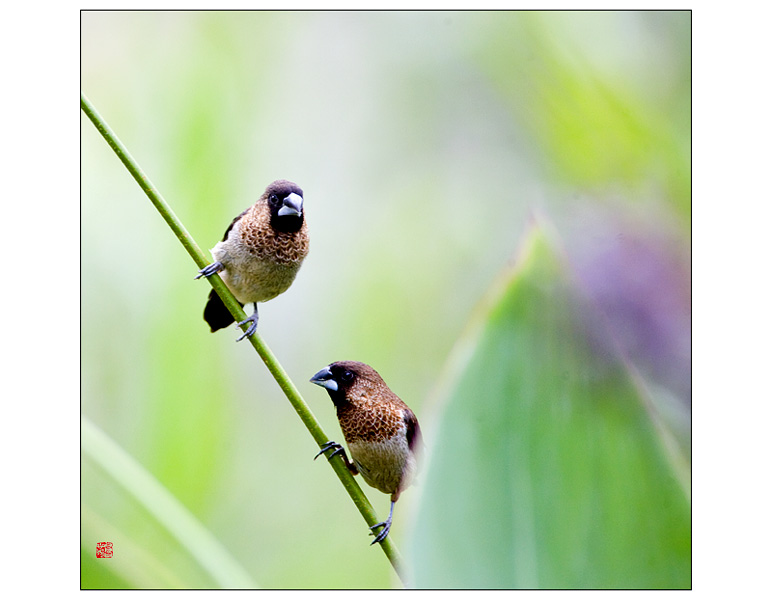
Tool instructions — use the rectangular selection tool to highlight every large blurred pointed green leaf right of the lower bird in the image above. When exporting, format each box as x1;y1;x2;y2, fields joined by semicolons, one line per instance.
411;227;691;588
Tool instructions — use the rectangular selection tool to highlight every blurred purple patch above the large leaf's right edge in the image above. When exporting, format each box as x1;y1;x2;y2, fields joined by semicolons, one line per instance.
567;206;691;409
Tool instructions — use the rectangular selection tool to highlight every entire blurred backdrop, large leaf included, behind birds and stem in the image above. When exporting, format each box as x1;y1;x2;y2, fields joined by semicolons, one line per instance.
81;11;691;588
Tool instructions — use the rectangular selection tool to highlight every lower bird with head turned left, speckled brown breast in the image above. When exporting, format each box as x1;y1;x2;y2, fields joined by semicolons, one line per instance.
311;361;423;545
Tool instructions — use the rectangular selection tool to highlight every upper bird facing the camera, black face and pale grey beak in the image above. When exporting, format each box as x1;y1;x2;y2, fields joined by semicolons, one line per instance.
195;179;309;342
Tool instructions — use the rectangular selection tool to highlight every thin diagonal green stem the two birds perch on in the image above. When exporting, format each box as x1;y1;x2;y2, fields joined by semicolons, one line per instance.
80;92;402;579
